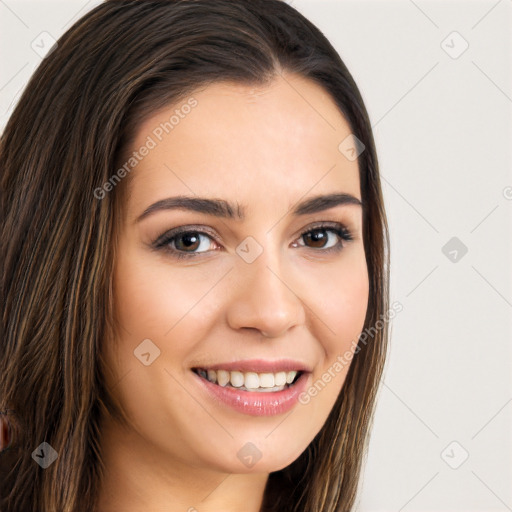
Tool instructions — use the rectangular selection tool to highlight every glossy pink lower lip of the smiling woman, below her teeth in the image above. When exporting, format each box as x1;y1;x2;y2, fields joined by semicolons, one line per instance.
192;372;310;416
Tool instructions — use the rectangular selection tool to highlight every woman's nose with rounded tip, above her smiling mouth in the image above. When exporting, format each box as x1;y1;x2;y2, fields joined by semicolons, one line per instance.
227;251;305;338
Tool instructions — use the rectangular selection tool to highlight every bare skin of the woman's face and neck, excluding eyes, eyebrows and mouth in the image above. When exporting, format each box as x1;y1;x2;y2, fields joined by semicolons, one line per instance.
99;74;368;512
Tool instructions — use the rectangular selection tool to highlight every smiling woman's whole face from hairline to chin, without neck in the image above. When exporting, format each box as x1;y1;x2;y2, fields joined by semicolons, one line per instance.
107;74;368;473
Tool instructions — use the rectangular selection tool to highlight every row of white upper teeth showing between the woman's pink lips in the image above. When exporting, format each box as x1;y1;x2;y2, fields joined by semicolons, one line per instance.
192;368;305;393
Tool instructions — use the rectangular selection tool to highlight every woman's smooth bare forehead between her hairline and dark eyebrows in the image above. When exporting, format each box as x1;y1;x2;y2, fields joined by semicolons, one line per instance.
123;75;360;216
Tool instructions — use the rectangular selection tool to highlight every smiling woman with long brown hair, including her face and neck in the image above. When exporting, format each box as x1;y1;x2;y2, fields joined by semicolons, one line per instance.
0;0;389;512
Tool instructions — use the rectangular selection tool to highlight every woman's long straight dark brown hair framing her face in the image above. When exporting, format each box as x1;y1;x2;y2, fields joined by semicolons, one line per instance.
0;0;389;512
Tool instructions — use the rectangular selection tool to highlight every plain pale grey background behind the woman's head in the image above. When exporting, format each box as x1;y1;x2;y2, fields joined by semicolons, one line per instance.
0;0;512;512
